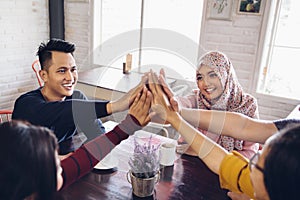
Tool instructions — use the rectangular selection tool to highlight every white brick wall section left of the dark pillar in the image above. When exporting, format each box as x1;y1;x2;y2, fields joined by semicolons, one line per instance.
0;0;49;109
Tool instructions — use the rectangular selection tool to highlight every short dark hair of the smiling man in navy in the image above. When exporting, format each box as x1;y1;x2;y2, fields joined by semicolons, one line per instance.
36;39;75;70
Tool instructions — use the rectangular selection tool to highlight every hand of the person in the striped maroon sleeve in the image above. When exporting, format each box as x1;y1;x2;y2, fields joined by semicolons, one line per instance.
128;86;152;126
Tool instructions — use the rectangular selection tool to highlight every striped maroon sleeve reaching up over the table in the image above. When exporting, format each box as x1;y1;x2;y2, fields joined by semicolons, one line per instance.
61;115;142;188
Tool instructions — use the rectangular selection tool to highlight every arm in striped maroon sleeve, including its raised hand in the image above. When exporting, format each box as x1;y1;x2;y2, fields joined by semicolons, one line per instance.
61;87;152;187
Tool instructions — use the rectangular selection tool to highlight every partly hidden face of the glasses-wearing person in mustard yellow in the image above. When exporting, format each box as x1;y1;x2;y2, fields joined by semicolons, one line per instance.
250;146;270;200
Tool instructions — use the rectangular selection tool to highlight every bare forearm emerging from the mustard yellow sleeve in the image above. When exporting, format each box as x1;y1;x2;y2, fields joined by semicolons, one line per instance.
170;115;228;174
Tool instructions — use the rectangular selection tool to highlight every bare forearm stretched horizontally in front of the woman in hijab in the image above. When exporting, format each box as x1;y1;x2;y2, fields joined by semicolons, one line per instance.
181;109;277;143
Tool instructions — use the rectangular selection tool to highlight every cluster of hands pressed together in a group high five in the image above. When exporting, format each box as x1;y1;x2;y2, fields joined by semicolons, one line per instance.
129;70;179;125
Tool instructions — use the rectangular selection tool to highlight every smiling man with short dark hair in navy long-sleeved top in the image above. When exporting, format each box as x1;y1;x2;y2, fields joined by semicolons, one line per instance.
12;39;143;155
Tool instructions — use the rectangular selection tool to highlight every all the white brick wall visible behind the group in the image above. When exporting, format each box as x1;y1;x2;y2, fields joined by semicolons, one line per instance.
0;0;299;119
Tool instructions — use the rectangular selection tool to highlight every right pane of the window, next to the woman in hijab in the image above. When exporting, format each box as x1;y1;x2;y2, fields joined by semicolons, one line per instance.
141;0;203;80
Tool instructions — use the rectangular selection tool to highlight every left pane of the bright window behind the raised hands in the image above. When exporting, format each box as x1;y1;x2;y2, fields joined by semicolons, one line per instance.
93;0;141;68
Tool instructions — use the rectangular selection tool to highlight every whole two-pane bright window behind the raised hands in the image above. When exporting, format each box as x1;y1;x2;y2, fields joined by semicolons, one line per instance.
93;0;203;80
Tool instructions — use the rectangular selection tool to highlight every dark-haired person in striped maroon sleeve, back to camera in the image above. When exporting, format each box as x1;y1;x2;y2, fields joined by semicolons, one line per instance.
0;86;152;200
